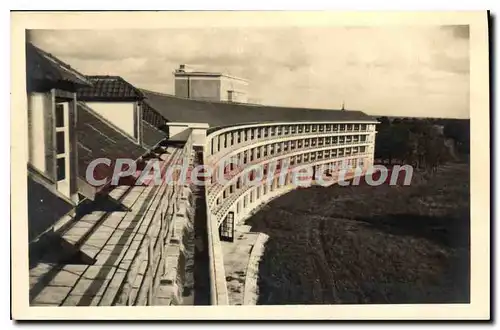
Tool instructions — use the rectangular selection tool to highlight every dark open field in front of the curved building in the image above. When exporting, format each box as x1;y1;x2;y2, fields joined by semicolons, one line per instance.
246;164;470;304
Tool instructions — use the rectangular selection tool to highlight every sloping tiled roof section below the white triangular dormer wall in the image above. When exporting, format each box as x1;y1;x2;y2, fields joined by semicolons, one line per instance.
77;102;147;186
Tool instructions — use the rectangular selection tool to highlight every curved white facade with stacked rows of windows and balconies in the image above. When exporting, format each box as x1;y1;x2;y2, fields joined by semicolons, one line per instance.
204;120;375;232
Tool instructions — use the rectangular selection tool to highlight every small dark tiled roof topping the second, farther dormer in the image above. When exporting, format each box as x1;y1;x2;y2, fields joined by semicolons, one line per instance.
77;76;144;101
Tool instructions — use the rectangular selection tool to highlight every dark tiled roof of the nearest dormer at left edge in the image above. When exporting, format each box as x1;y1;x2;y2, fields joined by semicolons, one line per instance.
26;43;91;86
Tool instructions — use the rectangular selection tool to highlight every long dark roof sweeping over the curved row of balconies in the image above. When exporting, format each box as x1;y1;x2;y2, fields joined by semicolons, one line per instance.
142;90;375;132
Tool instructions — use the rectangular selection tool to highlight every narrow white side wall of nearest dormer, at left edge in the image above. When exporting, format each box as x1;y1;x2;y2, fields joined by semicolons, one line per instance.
28;93;52;173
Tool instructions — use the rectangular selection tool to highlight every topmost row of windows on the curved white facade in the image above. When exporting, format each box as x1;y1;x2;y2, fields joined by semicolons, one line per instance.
211;124;371;154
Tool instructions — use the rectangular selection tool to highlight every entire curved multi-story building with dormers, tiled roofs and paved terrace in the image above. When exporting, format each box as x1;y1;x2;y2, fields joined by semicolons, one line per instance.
28;43;376;305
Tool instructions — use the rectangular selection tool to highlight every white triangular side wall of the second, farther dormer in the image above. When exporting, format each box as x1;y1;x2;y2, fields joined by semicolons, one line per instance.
86;102;137;139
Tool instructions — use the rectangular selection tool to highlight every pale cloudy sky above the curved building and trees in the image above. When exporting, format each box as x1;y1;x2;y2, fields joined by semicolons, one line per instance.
28;26;470;118
